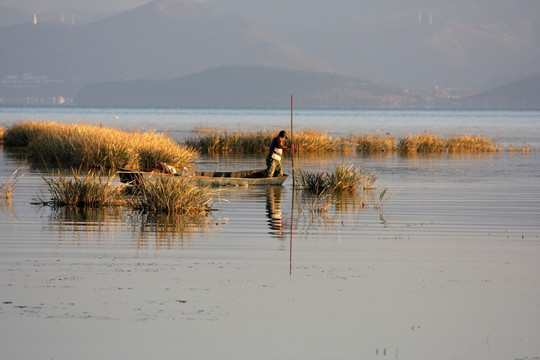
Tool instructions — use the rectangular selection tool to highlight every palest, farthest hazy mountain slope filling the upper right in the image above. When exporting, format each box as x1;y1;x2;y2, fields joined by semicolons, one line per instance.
205;0;540;90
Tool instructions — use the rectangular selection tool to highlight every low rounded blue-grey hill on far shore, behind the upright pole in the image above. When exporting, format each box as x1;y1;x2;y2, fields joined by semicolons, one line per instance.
75;66;424;108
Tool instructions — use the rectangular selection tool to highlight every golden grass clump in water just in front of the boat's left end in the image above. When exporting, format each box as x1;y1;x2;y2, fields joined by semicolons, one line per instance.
131;176;217;215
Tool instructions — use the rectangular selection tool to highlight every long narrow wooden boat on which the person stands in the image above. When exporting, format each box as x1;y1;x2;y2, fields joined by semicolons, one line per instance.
118;169;287;187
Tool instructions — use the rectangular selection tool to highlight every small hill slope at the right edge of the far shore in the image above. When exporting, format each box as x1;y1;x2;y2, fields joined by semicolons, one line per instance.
456;75;540;110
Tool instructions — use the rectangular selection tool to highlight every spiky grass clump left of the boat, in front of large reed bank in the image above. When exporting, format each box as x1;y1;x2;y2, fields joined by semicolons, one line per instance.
37;169;126;208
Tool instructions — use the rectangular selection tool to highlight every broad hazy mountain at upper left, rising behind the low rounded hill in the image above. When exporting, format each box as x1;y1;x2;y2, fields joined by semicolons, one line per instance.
0;0;335;104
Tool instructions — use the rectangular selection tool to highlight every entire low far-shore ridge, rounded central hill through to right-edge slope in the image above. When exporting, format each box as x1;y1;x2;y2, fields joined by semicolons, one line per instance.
75;66;540;110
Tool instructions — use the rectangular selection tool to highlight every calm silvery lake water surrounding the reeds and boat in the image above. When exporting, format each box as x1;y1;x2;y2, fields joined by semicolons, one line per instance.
0;107;540;360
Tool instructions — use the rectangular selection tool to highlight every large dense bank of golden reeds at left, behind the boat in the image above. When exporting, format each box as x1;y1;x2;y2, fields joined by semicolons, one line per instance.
4;121;197;169
